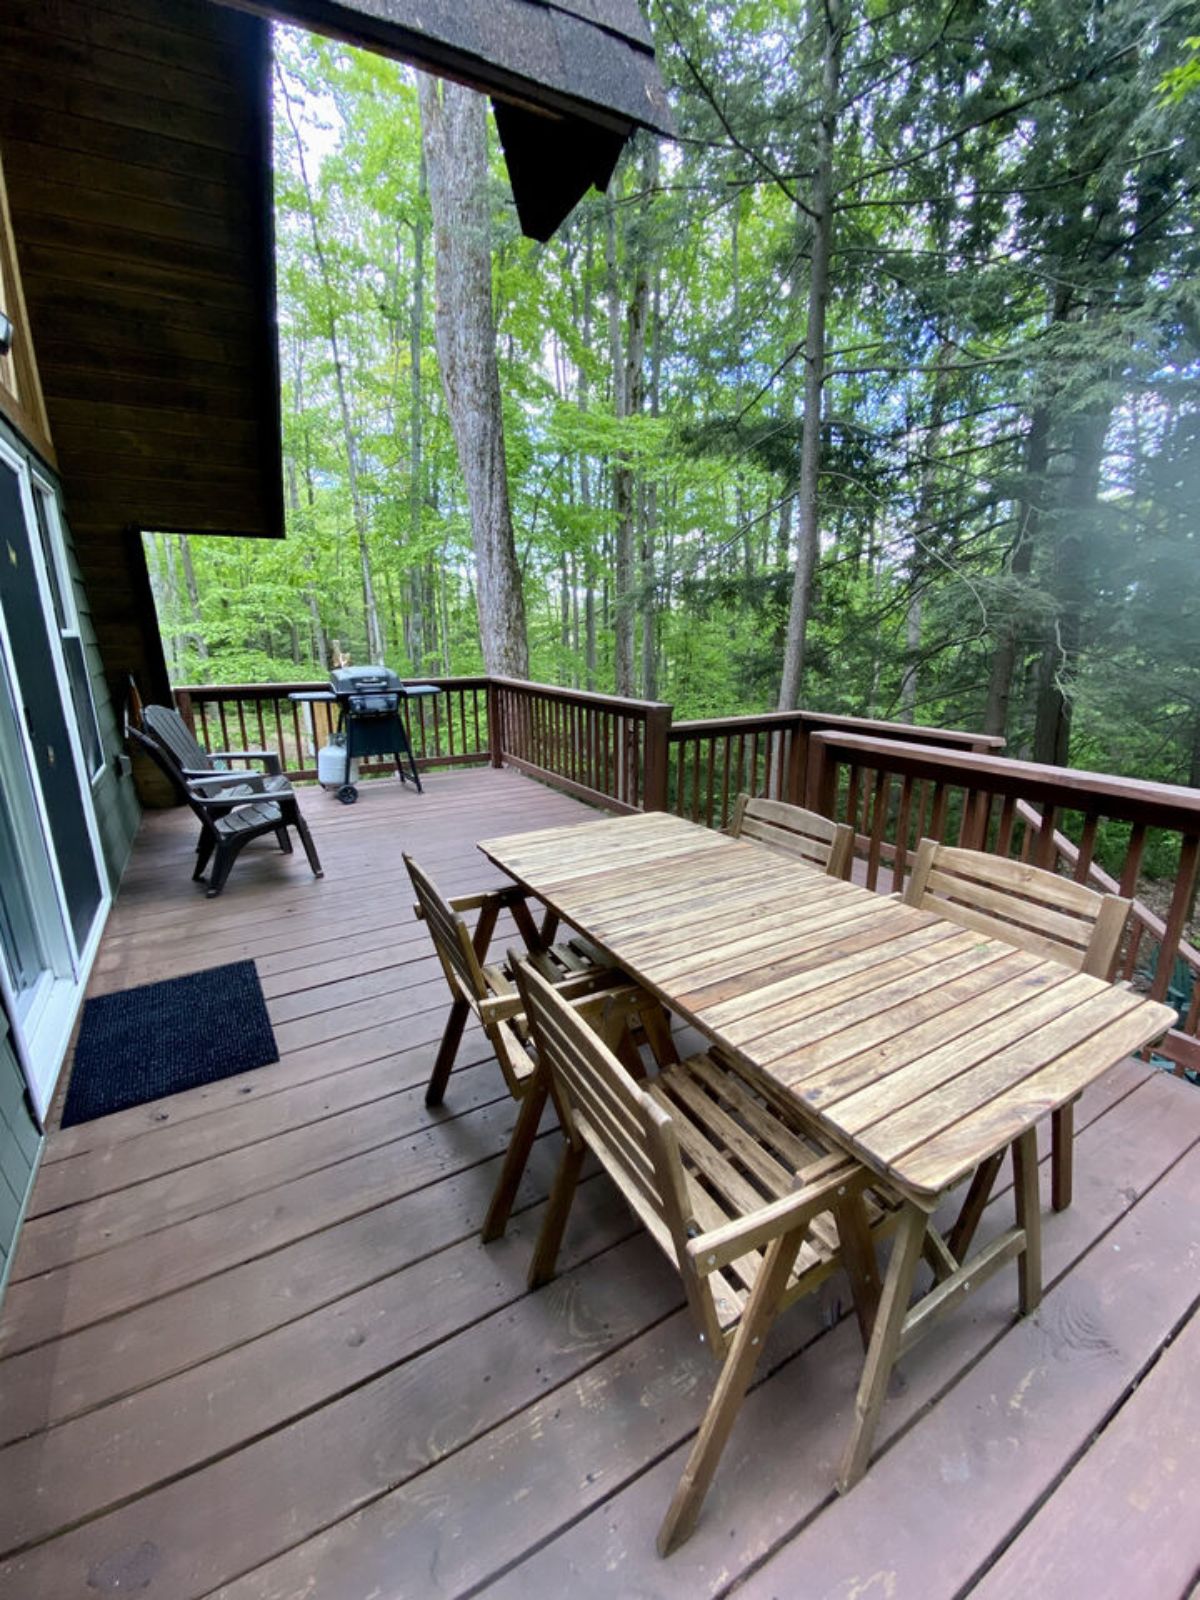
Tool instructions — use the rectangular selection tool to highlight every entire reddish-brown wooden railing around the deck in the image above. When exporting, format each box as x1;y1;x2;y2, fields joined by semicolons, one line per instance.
176;677;1200;1034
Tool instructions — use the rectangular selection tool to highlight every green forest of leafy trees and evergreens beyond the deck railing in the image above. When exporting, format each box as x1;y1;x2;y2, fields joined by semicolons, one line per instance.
146;0;1200;786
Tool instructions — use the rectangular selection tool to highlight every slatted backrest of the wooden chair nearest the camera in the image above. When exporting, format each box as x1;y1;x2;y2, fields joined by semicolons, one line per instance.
517;962;691;1270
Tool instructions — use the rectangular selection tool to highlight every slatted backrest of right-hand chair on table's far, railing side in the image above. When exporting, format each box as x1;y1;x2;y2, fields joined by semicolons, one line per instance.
904;838;1131;978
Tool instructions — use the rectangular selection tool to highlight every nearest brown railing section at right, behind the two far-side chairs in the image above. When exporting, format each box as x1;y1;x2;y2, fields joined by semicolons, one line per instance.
806;731;1200;1034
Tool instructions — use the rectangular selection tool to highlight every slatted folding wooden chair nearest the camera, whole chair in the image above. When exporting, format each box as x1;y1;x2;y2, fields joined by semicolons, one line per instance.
517;962;890;1555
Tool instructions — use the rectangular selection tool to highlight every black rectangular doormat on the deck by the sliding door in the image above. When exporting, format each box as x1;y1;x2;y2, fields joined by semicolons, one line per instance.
62;962;278;1128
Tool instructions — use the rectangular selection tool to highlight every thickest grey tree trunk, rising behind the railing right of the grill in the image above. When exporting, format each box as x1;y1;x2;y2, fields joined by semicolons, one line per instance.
418;74;530;678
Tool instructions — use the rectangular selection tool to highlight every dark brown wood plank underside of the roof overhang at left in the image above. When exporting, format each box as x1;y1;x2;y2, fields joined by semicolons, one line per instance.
0;0;283;698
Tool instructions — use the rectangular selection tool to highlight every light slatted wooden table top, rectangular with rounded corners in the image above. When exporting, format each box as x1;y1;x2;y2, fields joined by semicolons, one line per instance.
478;813;1176;1205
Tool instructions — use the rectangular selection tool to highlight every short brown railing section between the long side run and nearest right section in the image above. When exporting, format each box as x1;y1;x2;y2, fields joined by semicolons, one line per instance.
667;710;1005;827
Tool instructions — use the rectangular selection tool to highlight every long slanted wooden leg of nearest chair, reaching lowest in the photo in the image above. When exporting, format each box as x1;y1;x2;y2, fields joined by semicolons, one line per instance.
658;1227;808;1555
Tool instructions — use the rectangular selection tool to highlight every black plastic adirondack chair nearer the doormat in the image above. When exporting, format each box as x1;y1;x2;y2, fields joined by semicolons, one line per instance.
130;728;325;899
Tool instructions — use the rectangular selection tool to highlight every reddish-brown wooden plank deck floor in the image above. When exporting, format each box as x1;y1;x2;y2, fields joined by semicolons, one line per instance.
0;770;1200;1600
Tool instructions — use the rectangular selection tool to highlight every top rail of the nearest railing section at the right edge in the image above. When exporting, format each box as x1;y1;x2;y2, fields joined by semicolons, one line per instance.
813;733;1200;834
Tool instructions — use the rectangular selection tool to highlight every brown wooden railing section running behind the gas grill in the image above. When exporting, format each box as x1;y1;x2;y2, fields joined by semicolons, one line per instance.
174;677;490;779
